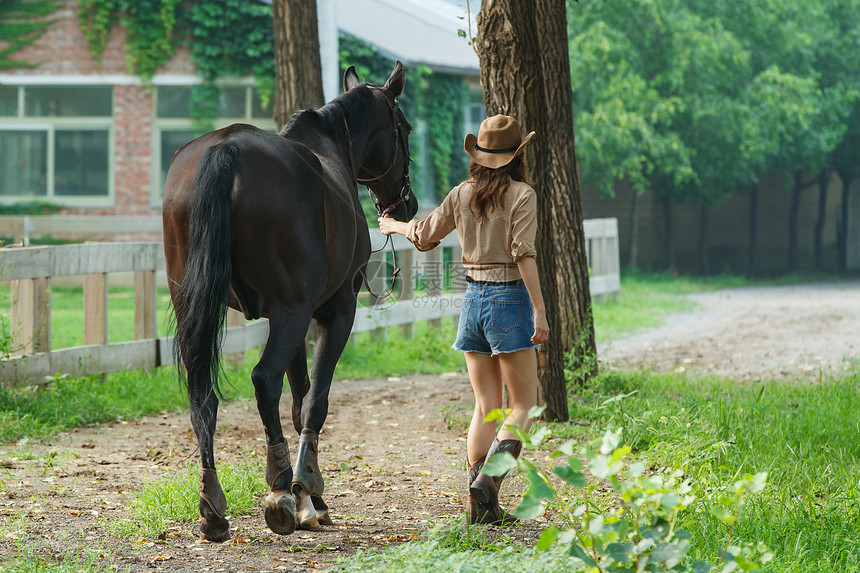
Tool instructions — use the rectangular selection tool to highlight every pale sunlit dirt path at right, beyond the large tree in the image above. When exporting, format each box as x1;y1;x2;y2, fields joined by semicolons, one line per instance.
598;281;860;379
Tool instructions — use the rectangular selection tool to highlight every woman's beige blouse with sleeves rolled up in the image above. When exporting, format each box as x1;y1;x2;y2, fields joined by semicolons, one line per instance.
406;180;537;282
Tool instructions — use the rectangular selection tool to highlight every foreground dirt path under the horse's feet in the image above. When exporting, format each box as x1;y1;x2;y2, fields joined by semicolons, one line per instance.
0;374;540;571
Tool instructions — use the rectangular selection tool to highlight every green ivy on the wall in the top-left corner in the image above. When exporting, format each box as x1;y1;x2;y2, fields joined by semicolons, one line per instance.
0;0;60;70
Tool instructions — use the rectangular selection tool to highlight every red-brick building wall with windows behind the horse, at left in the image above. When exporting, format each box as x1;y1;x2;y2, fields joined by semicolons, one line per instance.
0;0;275;215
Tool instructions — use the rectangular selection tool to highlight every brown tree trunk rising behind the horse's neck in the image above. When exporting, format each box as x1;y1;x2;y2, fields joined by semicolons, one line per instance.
272;0;325;127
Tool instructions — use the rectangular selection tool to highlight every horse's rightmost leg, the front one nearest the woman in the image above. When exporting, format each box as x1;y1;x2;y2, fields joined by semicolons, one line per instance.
292;293;355;529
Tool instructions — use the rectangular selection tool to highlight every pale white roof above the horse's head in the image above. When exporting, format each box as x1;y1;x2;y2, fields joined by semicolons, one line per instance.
336;0;480;75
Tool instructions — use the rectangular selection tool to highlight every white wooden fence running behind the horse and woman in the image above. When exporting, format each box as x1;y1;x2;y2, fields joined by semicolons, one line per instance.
0;218;619;383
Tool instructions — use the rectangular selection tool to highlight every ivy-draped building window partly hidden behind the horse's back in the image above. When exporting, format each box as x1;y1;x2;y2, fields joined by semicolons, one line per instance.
154;85;278;203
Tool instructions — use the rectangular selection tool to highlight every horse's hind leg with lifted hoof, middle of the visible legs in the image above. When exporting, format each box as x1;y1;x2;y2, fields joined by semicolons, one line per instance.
251;312;310;535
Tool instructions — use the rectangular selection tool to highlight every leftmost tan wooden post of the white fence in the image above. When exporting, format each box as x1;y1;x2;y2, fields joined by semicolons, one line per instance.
9;277;51;356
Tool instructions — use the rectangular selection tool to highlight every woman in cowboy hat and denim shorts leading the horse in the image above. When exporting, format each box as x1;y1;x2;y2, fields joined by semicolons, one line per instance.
379;115;549;524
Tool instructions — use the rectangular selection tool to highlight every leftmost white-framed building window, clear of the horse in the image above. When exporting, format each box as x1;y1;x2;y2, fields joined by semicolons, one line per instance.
0;86;113;204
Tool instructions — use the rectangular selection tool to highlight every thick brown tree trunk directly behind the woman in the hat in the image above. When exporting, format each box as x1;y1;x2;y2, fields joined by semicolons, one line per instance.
476;0;593;420
